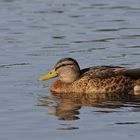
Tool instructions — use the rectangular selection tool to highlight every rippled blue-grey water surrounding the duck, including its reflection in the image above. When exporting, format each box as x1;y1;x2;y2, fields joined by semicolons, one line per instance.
0;0;140;140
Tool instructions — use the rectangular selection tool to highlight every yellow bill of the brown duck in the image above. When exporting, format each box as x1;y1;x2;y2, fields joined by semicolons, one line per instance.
38;69;58;81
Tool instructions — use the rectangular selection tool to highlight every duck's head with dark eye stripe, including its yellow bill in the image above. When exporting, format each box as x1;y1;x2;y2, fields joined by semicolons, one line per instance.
38;58;80;83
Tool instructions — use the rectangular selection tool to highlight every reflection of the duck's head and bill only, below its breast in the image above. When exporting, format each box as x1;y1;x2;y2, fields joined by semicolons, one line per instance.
40;96;81;120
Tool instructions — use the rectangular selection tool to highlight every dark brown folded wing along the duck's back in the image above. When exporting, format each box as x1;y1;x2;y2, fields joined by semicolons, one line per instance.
81;66;140;79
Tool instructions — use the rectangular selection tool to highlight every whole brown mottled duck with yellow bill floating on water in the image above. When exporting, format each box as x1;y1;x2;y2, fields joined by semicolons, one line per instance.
38;58;140;97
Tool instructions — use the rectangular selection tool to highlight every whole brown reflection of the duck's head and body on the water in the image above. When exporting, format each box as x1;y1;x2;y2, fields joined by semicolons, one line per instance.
39;96;140;121
